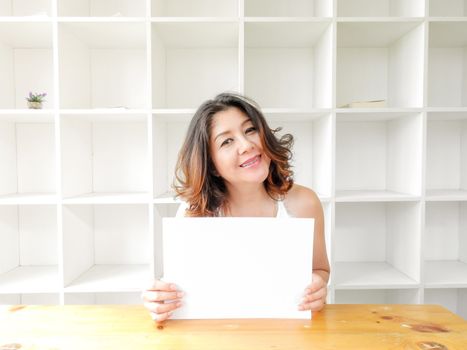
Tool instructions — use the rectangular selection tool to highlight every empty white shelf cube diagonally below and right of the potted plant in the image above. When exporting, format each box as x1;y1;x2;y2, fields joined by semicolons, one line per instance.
61;114;149;203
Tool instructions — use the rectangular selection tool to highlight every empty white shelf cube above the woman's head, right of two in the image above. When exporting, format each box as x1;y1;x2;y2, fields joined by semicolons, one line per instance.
245;21;333;109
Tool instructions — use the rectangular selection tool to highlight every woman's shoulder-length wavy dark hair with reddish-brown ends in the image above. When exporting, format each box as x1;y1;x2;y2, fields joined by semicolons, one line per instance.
173;92;293;216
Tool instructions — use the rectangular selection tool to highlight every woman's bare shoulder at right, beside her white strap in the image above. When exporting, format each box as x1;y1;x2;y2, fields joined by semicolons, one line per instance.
284;184;323;218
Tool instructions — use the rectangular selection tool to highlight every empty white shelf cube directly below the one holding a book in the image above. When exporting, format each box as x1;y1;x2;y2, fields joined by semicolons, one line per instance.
336;113;423;200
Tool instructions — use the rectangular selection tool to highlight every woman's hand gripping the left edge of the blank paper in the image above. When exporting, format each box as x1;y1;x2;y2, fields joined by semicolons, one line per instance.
141;280;183;322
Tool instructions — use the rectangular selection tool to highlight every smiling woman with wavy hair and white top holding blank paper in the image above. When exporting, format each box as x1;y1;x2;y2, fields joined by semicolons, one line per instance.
142;93;330;322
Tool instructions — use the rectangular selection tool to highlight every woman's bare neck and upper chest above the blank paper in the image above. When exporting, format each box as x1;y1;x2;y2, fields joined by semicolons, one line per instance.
224;183;276;216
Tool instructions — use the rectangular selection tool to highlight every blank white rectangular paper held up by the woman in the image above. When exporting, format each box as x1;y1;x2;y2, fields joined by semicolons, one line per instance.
162;218;314;319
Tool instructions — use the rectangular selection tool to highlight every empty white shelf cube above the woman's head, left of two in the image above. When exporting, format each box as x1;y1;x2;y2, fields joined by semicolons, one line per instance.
152;22;239;108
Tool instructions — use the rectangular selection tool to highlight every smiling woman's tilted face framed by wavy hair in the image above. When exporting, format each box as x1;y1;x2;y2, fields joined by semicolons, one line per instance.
210;107;271;184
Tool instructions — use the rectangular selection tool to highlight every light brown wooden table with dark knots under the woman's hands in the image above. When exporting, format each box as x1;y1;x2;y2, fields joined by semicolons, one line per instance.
0;305;467;350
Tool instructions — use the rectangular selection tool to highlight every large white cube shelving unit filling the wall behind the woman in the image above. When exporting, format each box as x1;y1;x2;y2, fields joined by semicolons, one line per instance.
0;0;467;318
